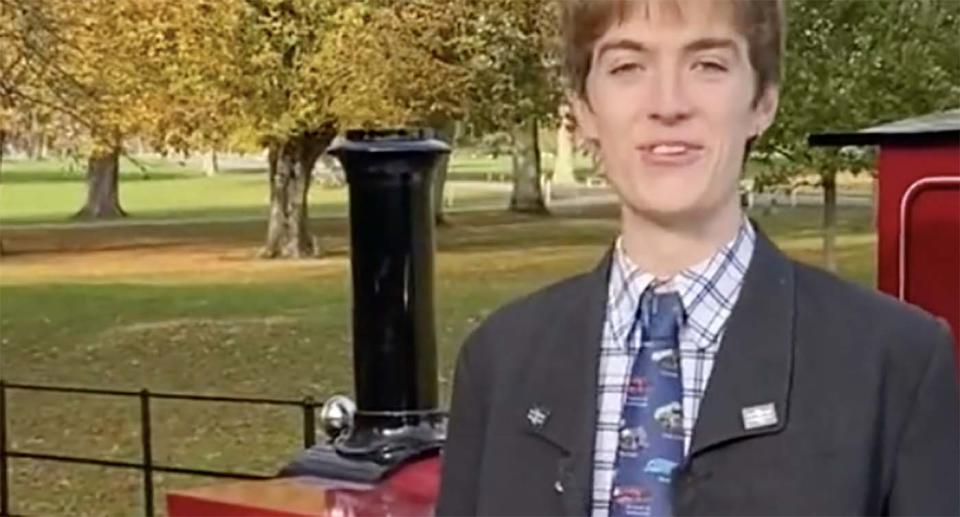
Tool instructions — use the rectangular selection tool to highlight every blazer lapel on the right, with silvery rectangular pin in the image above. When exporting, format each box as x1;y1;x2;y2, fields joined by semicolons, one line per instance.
690;229;794;458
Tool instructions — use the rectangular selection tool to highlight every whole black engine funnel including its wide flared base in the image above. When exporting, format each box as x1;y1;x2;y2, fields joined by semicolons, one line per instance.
281;130;450;481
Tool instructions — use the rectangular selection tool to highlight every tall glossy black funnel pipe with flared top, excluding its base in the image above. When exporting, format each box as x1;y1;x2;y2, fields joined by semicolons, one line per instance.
328;128;450;425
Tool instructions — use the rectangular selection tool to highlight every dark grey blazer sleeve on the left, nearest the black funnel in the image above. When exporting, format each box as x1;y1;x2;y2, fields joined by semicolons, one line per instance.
436;330;490;516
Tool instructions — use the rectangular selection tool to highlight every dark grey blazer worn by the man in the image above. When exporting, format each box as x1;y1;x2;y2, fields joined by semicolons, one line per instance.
437;232;960;515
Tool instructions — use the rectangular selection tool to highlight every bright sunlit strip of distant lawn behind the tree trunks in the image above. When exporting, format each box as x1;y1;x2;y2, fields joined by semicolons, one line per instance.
0;154;524;225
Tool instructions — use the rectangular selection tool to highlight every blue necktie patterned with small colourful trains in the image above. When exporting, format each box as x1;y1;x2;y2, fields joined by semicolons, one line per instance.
610;287;684;517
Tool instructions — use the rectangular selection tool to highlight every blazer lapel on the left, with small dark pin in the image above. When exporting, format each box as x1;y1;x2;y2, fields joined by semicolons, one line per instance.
519;251;612;515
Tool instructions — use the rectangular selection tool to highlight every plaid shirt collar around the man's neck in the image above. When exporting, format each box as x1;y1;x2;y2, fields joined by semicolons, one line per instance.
607;218;756;346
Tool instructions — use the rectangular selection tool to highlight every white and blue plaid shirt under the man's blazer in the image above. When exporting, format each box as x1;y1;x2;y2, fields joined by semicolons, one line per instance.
592;219;756;517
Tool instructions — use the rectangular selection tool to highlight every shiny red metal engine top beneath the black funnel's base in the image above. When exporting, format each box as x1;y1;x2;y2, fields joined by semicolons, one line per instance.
167;458;440;517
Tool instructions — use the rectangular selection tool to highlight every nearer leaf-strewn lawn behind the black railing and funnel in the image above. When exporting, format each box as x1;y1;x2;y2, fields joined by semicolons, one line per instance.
0;204;874;515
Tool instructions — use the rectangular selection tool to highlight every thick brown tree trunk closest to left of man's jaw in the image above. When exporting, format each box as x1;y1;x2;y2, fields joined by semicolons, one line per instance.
510;119;547;214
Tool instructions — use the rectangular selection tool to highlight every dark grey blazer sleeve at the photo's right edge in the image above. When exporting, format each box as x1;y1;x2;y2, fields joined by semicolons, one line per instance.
888;325;960;515
